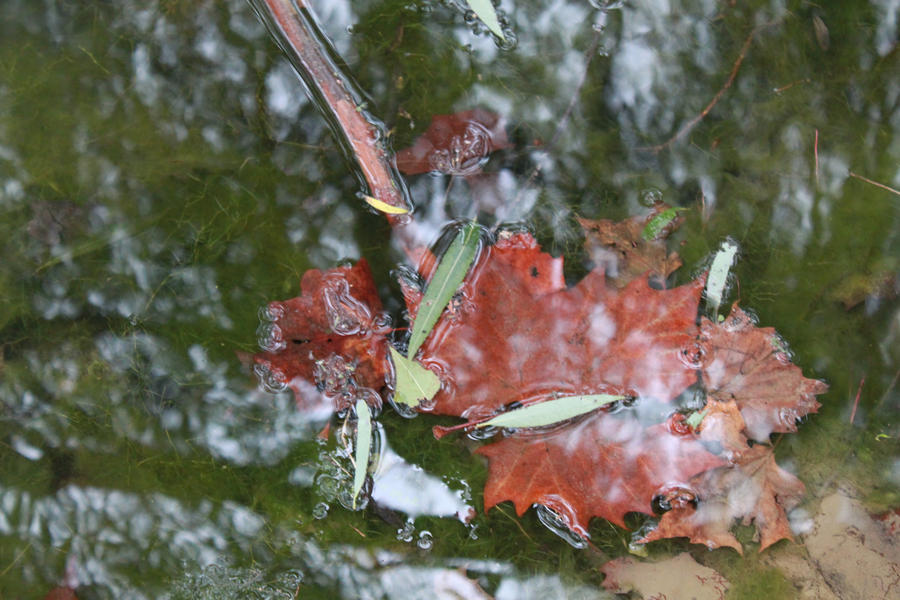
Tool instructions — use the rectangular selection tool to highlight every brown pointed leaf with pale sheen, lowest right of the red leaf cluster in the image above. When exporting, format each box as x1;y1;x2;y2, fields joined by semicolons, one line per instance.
641;445;804;553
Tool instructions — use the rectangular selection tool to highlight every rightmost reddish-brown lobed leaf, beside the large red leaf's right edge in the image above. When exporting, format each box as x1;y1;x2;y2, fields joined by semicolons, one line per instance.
700;305;828;441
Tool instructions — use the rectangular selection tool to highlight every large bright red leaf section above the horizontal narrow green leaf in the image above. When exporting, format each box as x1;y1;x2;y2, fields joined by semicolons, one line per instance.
408;233;703;418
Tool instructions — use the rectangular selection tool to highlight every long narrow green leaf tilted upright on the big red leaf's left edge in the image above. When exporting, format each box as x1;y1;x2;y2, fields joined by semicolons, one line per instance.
406;221;479;358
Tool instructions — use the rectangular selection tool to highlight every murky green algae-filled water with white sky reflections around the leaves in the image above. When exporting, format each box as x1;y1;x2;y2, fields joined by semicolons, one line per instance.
0;0;900;600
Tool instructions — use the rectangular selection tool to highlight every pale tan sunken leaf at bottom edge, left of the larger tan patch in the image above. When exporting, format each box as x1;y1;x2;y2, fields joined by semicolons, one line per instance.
600;552;730;600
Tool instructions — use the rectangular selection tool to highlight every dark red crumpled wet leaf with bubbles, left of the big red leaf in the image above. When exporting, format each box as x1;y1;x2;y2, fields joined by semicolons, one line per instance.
253;259;388;411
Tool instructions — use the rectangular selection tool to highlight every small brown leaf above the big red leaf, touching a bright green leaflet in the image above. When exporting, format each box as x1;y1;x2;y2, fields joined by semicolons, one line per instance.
578;202;683;288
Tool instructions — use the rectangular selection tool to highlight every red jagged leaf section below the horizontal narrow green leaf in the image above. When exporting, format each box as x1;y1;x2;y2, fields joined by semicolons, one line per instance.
476;411;723;537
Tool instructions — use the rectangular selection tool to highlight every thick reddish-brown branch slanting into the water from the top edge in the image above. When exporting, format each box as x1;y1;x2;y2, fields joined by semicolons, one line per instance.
254;0;411;216
